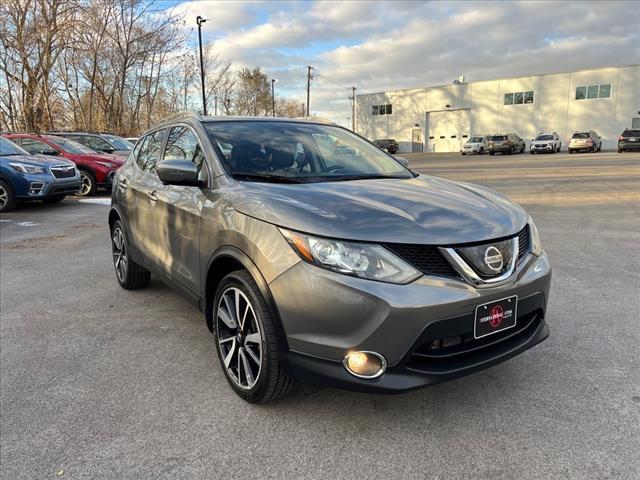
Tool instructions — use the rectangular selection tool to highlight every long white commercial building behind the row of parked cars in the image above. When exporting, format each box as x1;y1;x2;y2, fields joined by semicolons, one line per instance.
356;65;640;152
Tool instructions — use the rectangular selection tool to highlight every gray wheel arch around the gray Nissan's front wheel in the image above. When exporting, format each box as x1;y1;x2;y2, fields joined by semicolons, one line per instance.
201;246;289;352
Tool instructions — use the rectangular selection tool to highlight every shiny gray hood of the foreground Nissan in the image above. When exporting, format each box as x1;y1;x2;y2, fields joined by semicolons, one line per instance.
231;176;528;245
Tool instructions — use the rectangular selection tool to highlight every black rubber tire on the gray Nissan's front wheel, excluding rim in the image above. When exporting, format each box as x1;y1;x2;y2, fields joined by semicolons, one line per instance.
213;270;296;403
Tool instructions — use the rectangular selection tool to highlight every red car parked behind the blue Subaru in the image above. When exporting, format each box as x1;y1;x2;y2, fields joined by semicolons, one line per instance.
4;133;124;196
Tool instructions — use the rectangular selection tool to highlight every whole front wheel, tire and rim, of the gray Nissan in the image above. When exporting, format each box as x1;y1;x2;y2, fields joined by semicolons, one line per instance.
214;270;296;403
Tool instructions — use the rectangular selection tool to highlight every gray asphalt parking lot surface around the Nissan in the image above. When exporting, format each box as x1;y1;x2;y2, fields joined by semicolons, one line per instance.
0;152;640;480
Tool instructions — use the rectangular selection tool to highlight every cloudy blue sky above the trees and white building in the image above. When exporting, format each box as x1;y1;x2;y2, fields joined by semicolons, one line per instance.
167;0;640;125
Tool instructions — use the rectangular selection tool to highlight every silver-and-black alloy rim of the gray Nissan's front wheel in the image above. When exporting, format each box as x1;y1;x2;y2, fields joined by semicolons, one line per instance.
216;287;262;390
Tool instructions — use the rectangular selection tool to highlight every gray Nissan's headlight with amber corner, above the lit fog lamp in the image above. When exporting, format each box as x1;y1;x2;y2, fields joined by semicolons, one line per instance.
280;228;422;283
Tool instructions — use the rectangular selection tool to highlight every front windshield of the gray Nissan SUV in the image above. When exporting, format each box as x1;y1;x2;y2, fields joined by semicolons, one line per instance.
205;120;413;183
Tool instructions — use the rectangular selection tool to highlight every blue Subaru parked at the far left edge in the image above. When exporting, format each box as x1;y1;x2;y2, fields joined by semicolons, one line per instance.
0;137;81;212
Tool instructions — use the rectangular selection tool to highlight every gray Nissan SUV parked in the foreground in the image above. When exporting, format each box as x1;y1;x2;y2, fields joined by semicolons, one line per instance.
109;115;551;402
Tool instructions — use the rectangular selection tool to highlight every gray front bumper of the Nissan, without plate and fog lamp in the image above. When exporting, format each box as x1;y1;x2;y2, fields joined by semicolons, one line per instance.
270;254;551;392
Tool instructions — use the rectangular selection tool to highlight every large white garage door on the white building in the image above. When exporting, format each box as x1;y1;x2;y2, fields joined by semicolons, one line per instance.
427;110;471;152
